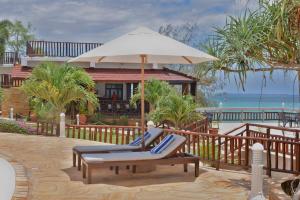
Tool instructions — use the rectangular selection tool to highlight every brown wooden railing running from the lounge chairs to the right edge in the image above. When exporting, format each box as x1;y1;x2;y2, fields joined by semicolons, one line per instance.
165;126;300;176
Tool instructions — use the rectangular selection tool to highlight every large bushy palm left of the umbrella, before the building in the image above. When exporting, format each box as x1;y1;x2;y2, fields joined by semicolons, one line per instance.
22;63;98;122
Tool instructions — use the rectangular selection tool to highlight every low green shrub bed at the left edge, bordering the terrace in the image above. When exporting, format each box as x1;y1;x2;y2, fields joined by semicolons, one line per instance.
0;119;29;134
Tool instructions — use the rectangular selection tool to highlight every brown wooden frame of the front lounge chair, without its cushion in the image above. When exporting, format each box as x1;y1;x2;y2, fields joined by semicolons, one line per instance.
82;142;199;184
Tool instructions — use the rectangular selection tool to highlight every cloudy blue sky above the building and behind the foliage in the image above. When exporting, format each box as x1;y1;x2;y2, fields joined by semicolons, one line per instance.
0;0;293;93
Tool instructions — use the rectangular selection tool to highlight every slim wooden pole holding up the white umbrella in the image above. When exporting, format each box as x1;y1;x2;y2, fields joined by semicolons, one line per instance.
141;55;146;149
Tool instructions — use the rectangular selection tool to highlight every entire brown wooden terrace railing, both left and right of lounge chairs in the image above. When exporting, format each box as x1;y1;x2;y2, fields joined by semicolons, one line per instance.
34;121;300;176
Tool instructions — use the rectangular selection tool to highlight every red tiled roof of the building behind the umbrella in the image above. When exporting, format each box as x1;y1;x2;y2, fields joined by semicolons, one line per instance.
12;66;195;82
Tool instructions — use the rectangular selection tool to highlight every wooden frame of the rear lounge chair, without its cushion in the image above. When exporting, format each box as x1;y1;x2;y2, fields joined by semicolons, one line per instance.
72;130;163;171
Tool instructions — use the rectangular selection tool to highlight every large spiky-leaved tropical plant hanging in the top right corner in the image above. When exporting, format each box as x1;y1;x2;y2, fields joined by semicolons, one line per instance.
203;0;300;85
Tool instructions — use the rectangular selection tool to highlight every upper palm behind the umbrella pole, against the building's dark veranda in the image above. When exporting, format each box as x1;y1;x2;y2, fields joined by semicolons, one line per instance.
130;79;173;111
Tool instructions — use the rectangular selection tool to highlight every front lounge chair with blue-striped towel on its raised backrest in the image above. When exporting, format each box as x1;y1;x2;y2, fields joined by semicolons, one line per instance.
81;134;199;184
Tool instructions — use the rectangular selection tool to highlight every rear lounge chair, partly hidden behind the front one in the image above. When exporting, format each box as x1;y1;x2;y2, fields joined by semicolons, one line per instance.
73;128;163;170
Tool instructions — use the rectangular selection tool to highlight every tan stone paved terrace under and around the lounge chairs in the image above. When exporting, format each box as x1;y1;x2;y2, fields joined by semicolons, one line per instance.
0;133;278;200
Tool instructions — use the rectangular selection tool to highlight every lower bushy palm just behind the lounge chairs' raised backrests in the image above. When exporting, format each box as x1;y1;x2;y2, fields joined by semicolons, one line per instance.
149;91;202;129
